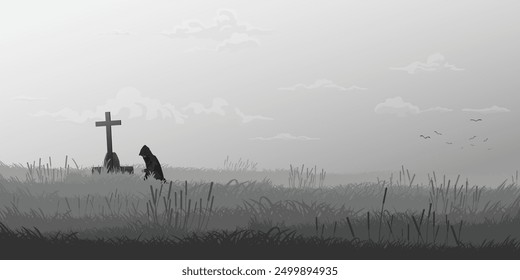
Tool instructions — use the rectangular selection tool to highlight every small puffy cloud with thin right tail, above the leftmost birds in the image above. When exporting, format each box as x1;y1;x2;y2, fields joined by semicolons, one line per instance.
374;96;453;117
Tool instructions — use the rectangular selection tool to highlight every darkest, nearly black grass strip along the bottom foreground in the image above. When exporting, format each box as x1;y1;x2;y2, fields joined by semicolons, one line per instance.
0;223;520;260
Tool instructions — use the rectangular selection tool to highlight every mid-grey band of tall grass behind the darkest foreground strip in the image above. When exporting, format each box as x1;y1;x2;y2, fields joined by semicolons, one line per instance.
0;160;520;246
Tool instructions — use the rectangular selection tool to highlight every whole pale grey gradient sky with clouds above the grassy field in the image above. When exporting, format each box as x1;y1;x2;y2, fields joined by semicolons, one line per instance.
0;0;520;185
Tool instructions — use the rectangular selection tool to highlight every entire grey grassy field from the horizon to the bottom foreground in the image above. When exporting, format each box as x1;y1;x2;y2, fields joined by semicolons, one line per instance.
0;159;520;259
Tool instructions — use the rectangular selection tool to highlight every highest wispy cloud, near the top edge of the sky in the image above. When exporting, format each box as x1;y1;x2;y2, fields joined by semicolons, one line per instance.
161;9;269;41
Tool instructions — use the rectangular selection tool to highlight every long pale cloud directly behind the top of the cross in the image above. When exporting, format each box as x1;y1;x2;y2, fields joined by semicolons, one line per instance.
33;87;188;124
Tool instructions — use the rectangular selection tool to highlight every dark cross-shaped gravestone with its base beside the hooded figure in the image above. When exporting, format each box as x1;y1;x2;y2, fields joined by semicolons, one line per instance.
92;112;134;174
